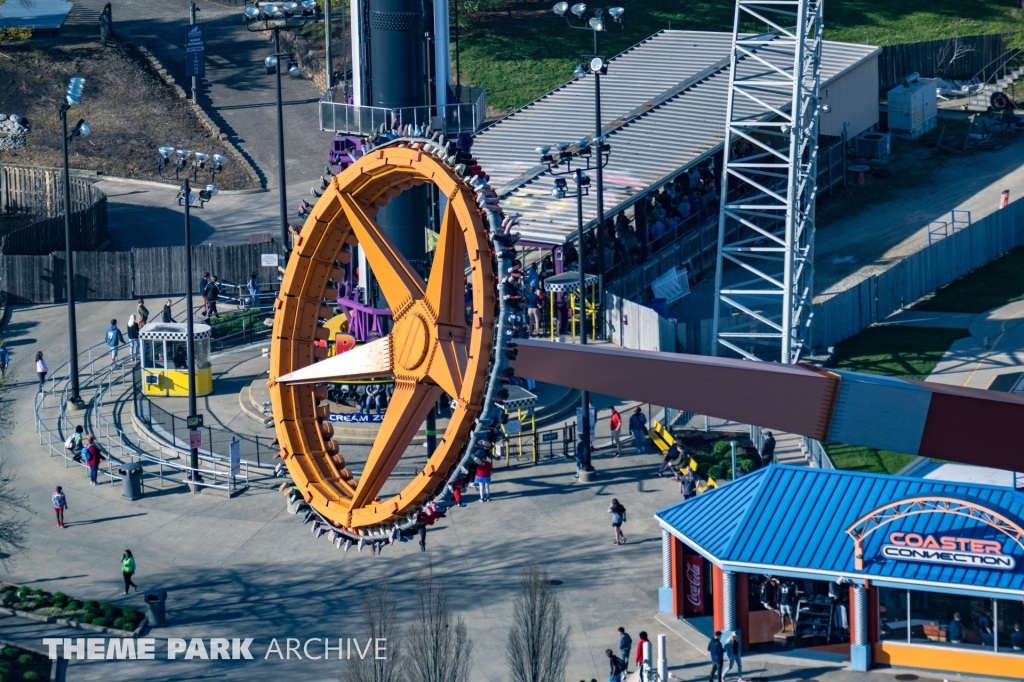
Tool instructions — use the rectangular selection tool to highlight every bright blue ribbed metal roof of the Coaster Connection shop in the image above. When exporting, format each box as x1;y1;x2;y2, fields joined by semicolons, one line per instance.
655;466;1024;592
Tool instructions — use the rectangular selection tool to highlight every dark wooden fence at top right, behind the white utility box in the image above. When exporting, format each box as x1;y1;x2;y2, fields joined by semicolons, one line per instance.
879;33;1014;90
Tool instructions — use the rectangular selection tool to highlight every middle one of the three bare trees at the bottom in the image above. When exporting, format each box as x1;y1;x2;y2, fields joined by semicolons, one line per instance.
406;568;473;682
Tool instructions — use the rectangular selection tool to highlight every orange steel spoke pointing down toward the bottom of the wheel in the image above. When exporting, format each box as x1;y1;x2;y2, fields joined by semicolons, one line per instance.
351;380;441;509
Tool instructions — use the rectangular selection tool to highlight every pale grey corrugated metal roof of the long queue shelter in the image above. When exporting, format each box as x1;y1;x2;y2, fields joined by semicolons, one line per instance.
473;31;880;244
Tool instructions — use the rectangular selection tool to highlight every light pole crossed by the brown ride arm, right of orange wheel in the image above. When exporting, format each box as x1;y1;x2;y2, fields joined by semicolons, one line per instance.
537;135;611;471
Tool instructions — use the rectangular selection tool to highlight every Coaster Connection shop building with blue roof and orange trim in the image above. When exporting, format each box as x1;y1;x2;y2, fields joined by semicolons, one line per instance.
655;465;1024;679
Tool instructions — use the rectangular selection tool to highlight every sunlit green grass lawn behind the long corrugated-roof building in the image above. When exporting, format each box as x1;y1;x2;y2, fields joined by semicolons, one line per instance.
453;0;1024;113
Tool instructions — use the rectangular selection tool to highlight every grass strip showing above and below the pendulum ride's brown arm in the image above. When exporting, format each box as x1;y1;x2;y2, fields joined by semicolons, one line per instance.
825;327;969;474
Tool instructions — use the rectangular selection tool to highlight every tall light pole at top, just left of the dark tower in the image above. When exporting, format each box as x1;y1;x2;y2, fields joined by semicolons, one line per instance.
242;0;321;249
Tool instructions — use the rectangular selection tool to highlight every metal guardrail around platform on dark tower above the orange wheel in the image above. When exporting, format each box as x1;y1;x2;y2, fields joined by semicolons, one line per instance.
319;86;486;136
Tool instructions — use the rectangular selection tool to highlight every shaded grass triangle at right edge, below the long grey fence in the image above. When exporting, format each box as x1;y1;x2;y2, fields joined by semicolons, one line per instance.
913;240;1024;312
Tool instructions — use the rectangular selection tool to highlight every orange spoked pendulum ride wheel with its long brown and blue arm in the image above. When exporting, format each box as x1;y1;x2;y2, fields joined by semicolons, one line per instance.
269;131;1024;548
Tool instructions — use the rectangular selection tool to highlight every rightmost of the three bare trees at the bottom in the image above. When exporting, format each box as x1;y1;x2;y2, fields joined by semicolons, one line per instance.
505;565;569;682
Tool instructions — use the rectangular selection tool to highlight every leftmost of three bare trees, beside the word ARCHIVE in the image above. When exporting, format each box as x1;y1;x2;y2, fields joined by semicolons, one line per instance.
338;579;402;682
